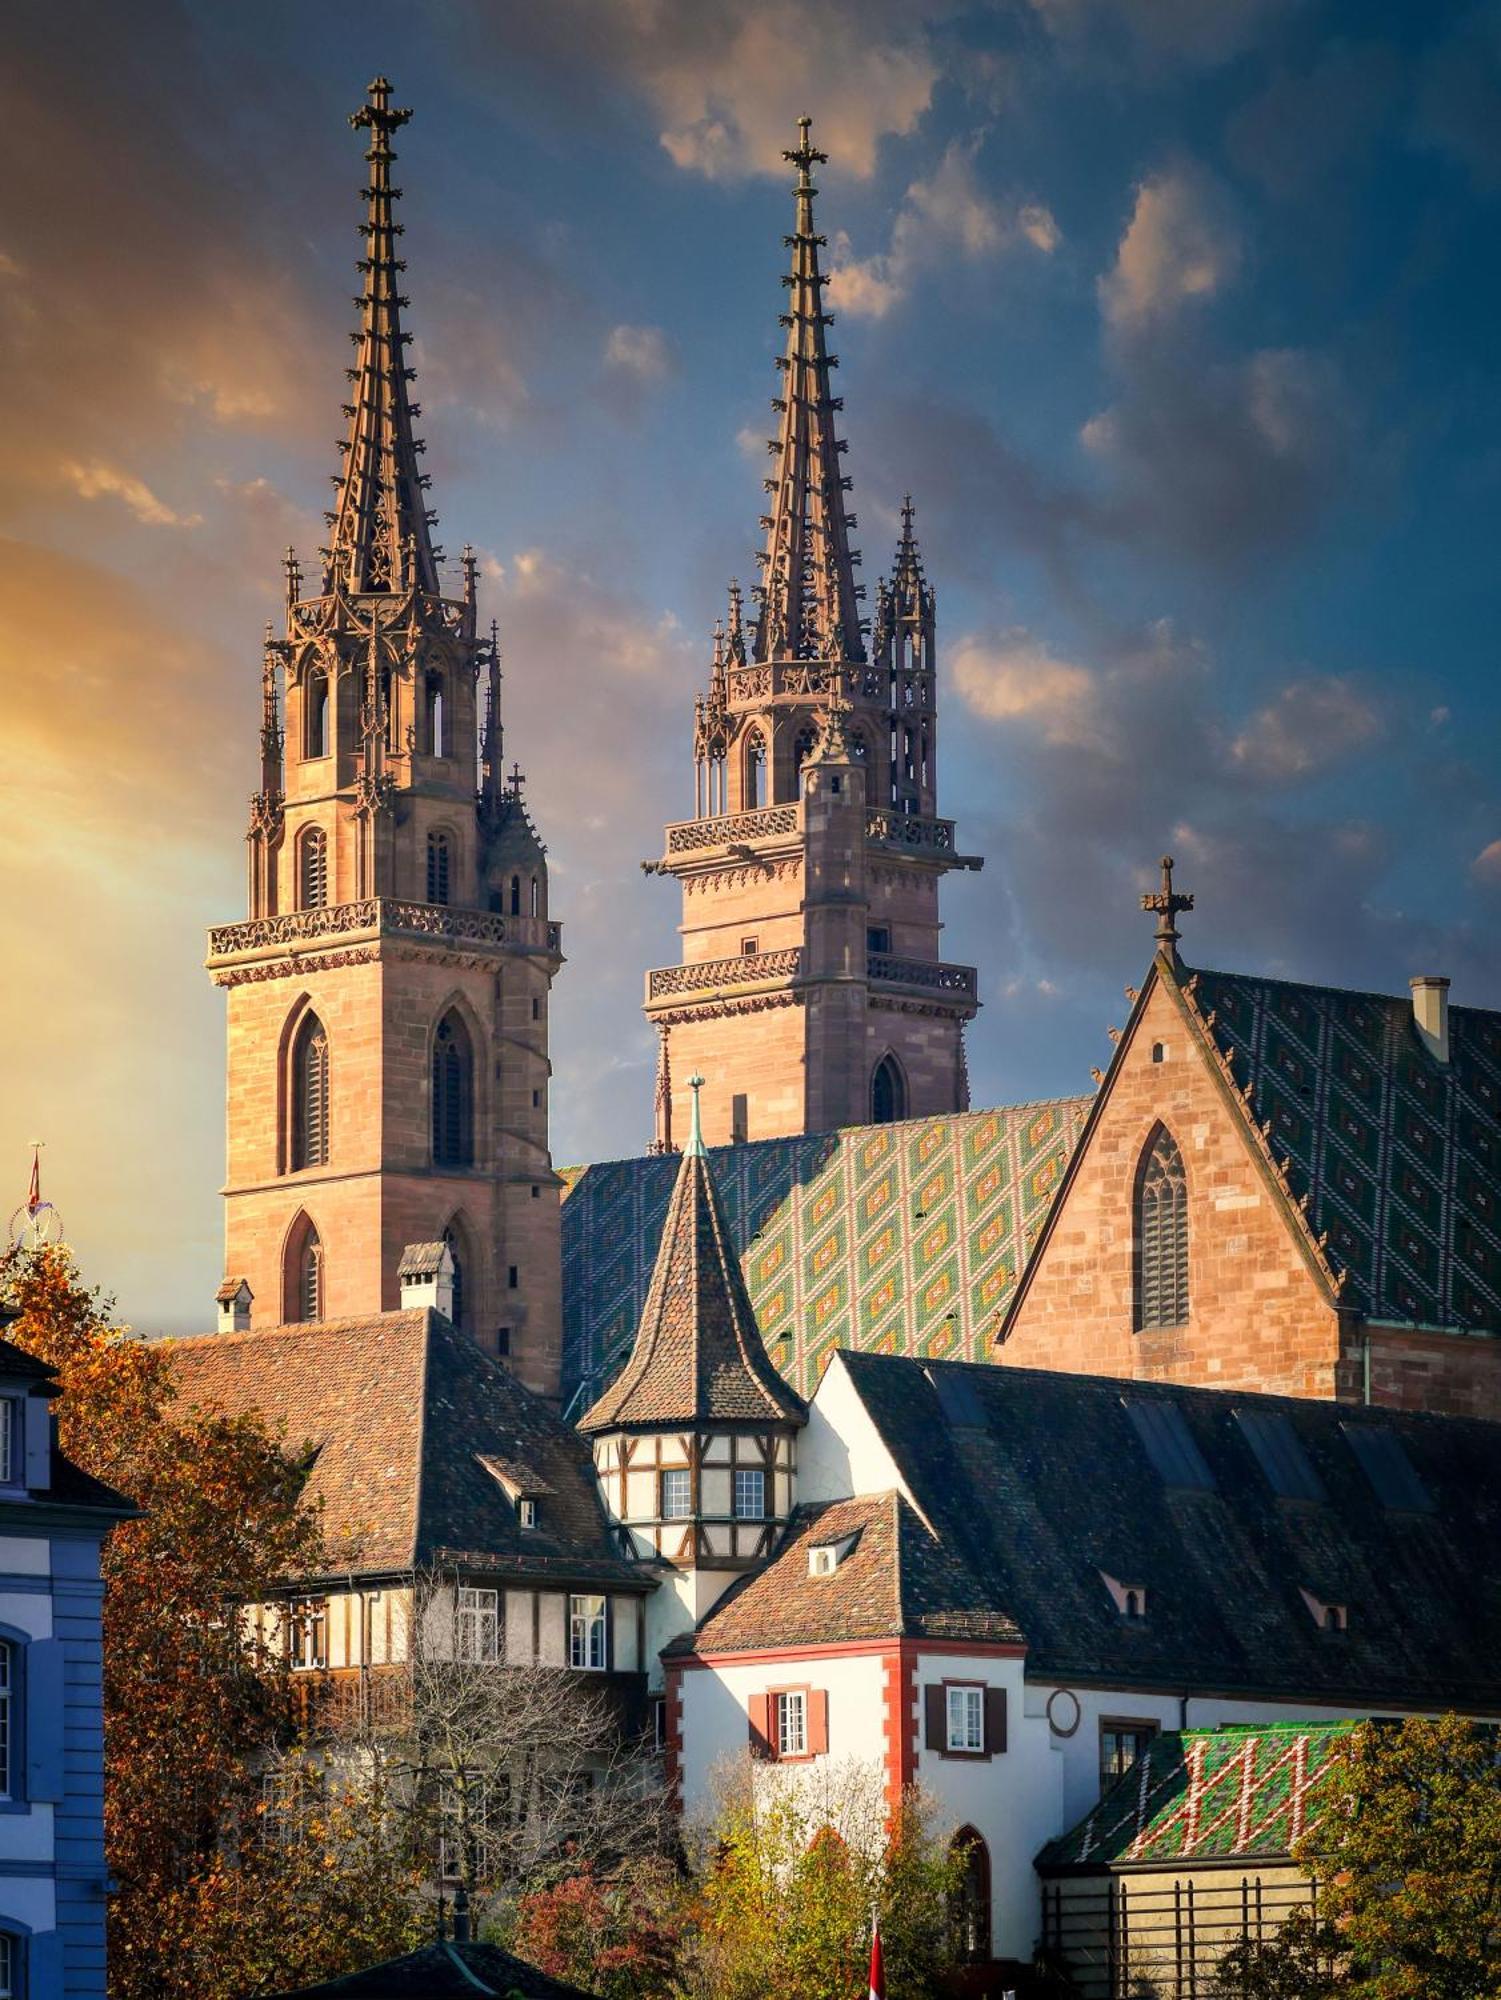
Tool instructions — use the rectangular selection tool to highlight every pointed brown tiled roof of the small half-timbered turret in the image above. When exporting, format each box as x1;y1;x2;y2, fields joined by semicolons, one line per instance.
578;1150;807;1430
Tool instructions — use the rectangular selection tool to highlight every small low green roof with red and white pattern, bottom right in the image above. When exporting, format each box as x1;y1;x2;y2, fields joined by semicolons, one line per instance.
1037;1722;1355;1874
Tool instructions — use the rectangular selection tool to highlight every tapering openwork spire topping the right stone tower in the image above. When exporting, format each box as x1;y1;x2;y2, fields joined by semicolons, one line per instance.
755;118;865;660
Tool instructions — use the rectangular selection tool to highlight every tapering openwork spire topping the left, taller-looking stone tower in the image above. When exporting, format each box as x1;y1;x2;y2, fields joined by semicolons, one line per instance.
324;76;438;594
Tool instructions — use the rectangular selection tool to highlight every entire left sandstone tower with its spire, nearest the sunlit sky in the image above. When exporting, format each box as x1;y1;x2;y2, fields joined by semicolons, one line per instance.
208;78;562;1392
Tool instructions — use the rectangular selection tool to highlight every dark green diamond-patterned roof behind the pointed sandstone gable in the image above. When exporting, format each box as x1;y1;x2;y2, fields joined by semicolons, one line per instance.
1195;972;1501;1332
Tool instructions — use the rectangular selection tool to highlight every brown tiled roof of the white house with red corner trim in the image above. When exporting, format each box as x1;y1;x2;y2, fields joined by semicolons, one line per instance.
668;1492;1021;1654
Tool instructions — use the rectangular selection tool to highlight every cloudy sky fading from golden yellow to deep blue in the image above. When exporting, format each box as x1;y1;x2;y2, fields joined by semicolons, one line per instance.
0;0;1501;1326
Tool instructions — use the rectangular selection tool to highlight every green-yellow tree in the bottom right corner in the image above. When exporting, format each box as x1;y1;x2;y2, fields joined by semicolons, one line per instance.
1299;1714;1501;2000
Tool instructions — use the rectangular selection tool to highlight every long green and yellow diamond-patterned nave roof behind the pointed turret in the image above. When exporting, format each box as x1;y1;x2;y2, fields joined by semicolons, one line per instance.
562;1098;1093;1406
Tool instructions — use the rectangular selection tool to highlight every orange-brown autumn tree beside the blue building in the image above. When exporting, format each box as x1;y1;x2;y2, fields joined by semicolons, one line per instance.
0;1246;426;2000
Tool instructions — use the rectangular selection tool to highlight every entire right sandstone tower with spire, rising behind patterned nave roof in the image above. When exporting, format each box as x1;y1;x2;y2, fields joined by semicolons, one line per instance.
646;118;981;1150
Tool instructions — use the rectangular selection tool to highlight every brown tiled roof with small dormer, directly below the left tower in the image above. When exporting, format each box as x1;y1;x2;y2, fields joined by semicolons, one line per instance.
170;1310;642;1588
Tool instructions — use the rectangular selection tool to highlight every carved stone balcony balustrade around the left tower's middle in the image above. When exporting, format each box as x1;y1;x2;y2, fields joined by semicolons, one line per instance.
208;896;562;984
